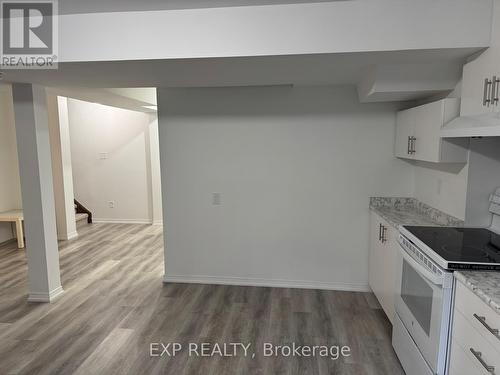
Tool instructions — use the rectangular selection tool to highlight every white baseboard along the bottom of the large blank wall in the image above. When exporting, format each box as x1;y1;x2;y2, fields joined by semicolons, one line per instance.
163;275;370;292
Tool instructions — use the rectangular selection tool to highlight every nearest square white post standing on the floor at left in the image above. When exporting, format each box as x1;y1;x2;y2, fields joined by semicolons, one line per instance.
12;84;63;302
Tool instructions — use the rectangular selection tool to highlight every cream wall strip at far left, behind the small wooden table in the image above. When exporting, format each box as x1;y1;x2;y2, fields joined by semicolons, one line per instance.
0;86;22;242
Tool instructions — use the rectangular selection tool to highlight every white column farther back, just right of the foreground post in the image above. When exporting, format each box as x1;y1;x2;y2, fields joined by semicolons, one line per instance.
47;94;78;240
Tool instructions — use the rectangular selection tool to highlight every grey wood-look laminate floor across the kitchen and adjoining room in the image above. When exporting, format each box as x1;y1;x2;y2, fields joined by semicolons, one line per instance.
0;224;403;375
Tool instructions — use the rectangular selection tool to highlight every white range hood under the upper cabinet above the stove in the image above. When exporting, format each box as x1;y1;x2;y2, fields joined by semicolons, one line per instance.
441;112;500;138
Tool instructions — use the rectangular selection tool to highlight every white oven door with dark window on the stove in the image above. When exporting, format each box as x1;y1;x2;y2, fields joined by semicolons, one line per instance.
395;247;452;374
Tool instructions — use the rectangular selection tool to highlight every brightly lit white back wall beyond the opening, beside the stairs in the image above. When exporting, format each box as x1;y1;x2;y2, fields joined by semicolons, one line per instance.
68;99;159;223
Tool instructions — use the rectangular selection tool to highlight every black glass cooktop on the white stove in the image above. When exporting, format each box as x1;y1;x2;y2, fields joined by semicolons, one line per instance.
405;226;500;270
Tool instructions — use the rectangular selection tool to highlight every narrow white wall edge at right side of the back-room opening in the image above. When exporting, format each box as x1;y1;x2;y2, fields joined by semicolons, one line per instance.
147;114;163;225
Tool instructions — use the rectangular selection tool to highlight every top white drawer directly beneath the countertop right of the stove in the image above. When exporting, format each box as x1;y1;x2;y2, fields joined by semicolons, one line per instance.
455;282;500;356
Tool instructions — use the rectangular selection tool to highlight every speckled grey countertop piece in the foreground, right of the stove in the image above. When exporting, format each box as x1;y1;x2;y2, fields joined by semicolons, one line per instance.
453;271;500;314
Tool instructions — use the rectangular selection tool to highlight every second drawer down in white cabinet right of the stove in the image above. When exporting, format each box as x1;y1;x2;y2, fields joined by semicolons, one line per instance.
452;310;500;374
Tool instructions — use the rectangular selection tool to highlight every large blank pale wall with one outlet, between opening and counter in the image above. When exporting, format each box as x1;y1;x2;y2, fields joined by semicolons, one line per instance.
159;87;413;290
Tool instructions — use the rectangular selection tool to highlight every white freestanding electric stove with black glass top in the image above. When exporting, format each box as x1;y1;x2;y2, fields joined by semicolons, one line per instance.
392;188;500;375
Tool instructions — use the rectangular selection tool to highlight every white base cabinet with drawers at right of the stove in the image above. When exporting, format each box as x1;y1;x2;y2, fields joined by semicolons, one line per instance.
450;282;500;375
